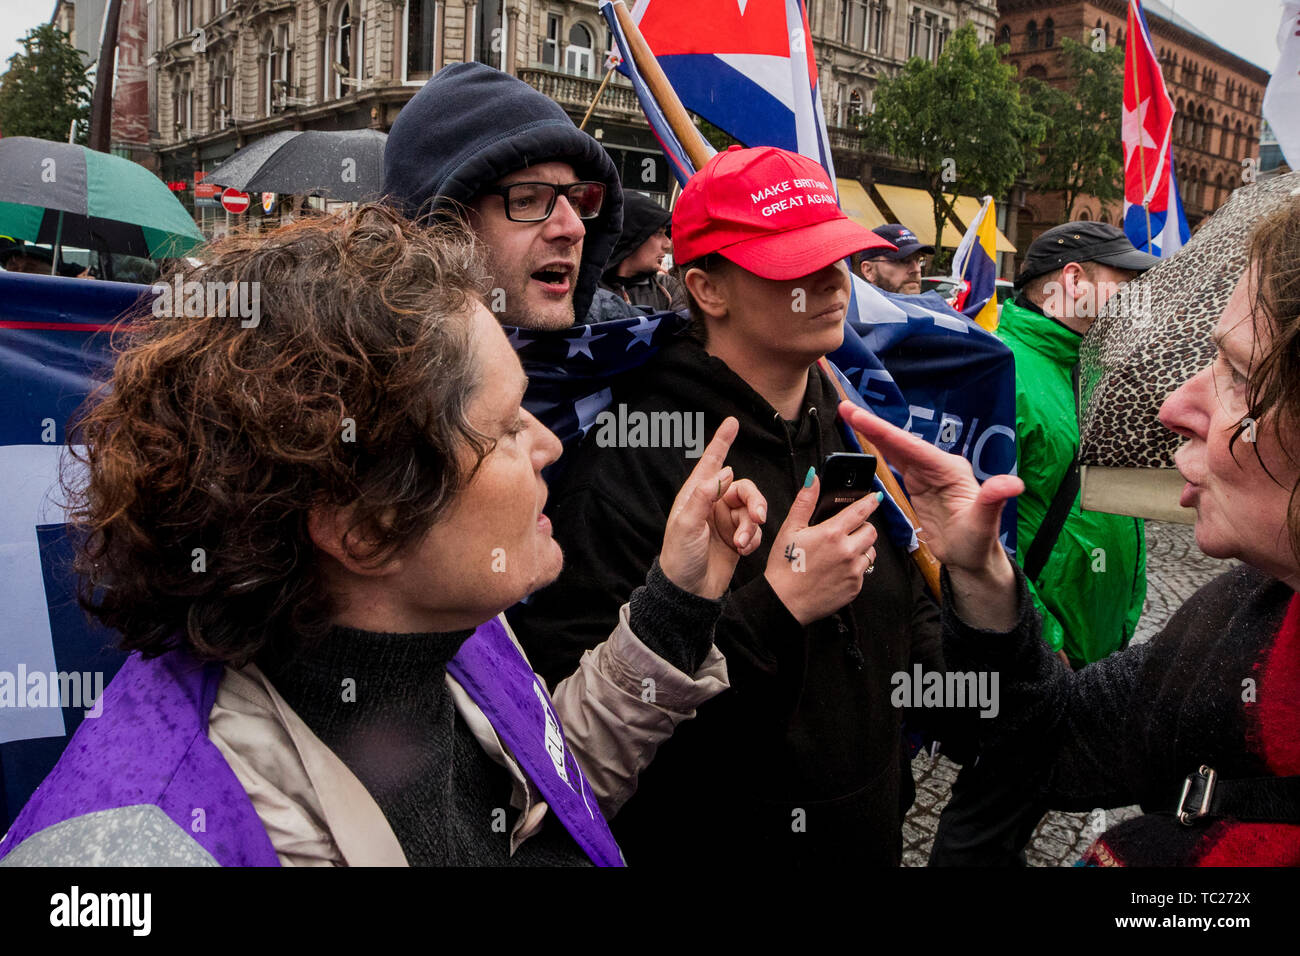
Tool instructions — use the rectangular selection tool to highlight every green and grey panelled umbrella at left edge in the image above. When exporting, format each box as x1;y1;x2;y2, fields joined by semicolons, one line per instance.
0;137;204;265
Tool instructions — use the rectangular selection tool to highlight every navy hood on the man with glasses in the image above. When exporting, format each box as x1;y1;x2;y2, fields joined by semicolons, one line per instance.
384;62;623;321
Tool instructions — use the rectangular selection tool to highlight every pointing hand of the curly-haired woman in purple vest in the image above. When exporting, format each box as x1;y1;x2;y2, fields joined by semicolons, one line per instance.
659;418;767;598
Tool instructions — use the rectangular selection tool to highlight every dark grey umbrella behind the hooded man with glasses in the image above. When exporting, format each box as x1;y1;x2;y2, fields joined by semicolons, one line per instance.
205;130;389;203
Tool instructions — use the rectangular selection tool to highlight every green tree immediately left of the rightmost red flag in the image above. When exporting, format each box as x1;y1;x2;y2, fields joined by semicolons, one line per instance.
1026;38;1125;219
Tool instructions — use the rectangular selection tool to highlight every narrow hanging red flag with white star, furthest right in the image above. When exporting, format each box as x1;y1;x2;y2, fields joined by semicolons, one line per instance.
1122;0;1191;256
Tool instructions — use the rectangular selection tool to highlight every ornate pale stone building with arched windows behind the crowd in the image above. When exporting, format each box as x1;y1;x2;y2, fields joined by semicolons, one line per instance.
147;0;997;230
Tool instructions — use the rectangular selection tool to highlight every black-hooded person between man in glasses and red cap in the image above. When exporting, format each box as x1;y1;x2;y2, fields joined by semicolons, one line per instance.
601;193;686;312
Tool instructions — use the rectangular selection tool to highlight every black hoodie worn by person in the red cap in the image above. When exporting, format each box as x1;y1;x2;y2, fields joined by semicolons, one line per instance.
510;337;943;865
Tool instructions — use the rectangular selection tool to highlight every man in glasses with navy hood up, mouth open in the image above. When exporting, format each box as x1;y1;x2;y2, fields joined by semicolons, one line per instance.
384;62;640;329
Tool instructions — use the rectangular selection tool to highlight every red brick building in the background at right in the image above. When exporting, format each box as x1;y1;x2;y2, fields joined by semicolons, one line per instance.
997;0;1269;269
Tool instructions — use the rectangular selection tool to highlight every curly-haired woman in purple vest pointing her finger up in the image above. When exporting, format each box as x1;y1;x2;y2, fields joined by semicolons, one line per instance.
0;207;764;865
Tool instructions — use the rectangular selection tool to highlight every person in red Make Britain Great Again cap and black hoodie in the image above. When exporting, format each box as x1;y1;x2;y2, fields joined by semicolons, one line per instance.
511;147;961;866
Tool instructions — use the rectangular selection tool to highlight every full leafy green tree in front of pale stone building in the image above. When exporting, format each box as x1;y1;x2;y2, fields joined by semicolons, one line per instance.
862;23;1047;268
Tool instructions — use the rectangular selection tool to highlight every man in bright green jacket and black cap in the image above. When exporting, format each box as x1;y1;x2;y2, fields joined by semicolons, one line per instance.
930;221;1160;866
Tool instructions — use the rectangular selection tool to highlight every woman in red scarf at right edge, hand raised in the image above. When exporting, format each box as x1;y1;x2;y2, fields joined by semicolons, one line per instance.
841;199;1300;866
